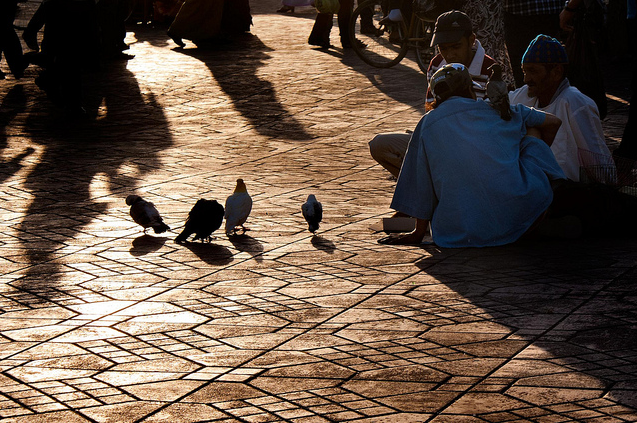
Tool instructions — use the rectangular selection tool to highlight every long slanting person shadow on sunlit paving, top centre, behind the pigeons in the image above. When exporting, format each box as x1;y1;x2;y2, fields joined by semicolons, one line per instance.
175;33;314;141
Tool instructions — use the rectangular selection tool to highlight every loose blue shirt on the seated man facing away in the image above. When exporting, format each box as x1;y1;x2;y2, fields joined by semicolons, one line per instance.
391;97;565;247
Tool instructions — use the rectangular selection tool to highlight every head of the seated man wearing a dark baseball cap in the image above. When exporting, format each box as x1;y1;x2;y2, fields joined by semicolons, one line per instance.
431;10;476;66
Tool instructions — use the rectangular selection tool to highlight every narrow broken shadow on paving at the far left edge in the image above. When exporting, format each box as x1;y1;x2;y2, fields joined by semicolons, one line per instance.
0;84;35;183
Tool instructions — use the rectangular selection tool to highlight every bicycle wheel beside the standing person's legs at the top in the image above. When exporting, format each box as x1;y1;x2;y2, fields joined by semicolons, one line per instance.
350;0;409;68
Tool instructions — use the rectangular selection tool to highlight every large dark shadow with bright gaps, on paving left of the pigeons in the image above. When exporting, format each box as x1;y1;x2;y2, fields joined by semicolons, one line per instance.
15;58;173;295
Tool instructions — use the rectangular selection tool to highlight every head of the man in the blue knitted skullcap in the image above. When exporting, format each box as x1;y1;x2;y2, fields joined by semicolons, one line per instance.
522;34;568;104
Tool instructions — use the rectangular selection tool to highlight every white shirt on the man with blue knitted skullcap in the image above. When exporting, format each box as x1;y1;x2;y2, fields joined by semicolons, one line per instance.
509;79;611;181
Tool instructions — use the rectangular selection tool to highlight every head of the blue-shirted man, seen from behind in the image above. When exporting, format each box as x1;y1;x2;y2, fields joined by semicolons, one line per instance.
429;63;476;108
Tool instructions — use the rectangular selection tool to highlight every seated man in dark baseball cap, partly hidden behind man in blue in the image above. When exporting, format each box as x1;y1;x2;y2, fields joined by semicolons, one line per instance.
369;10;496;177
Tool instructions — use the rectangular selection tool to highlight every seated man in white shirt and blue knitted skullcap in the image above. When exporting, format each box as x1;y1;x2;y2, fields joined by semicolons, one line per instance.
509;35;611;181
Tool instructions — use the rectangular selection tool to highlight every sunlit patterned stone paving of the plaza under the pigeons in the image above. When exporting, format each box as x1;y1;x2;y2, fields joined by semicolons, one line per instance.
0;0;637;423
